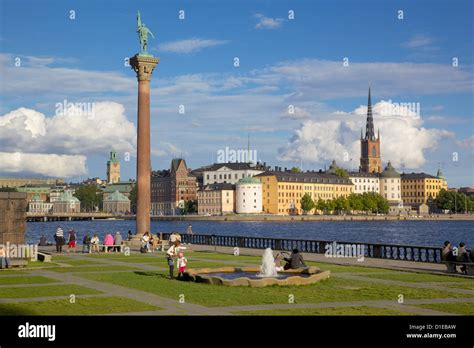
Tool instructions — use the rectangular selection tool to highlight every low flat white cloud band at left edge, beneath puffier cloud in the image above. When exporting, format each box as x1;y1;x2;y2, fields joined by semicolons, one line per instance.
0;152;87;177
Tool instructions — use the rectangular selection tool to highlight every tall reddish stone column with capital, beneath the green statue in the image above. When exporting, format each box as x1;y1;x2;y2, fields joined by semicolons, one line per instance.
130;54;160;235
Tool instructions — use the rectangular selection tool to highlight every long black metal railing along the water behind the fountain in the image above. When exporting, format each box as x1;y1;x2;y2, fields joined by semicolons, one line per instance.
162;233;442;263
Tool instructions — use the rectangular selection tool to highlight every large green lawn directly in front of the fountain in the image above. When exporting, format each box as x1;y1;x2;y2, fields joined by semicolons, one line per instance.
80;271;474;307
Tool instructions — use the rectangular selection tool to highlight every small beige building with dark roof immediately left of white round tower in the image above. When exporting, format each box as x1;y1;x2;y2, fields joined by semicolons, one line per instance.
198;184;235;215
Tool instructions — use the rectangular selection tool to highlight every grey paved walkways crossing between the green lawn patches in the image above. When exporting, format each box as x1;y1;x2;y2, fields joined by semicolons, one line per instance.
0;249;474;316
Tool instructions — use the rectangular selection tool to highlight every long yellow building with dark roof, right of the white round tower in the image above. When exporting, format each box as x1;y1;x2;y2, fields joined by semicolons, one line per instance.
256;172;354;215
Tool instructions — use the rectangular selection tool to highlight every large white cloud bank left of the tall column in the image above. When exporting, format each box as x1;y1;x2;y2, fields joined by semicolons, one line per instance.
0;102;136;176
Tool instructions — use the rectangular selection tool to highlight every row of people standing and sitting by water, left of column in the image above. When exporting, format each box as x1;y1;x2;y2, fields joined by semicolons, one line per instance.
52;226;124;253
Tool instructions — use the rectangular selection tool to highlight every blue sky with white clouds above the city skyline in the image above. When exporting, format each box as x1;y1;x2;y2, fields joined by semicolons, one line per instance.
0;0;474;186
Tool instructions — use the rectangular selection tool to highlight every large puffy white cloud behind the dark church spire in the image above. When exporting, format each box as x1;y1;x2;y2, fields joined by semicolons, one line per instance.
279;101;453;169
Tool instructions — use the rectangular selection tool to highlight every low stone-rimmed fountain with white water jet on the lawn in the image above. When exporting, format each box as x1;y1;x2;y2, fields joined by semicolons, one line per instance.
183;248;331;287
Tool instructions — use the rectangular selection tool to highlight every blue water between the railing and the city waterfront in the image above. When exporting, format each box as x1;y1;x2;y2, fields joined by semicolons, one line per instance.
26;220;474;247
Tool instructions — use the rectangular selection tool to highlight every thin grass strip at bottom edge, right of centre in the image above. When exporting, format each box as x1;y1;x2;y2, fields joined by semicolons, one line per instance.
233;306;412;316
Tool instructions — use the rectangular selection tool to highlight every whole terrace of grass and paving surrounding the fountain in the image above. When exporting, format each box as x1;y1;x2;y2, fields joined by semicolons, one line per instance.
0;245;474;315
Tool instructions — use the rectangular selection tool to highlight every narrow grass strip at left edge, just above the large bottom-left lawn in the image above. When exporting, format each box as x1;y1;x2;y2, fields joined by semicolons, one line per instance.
0;284;102;298
